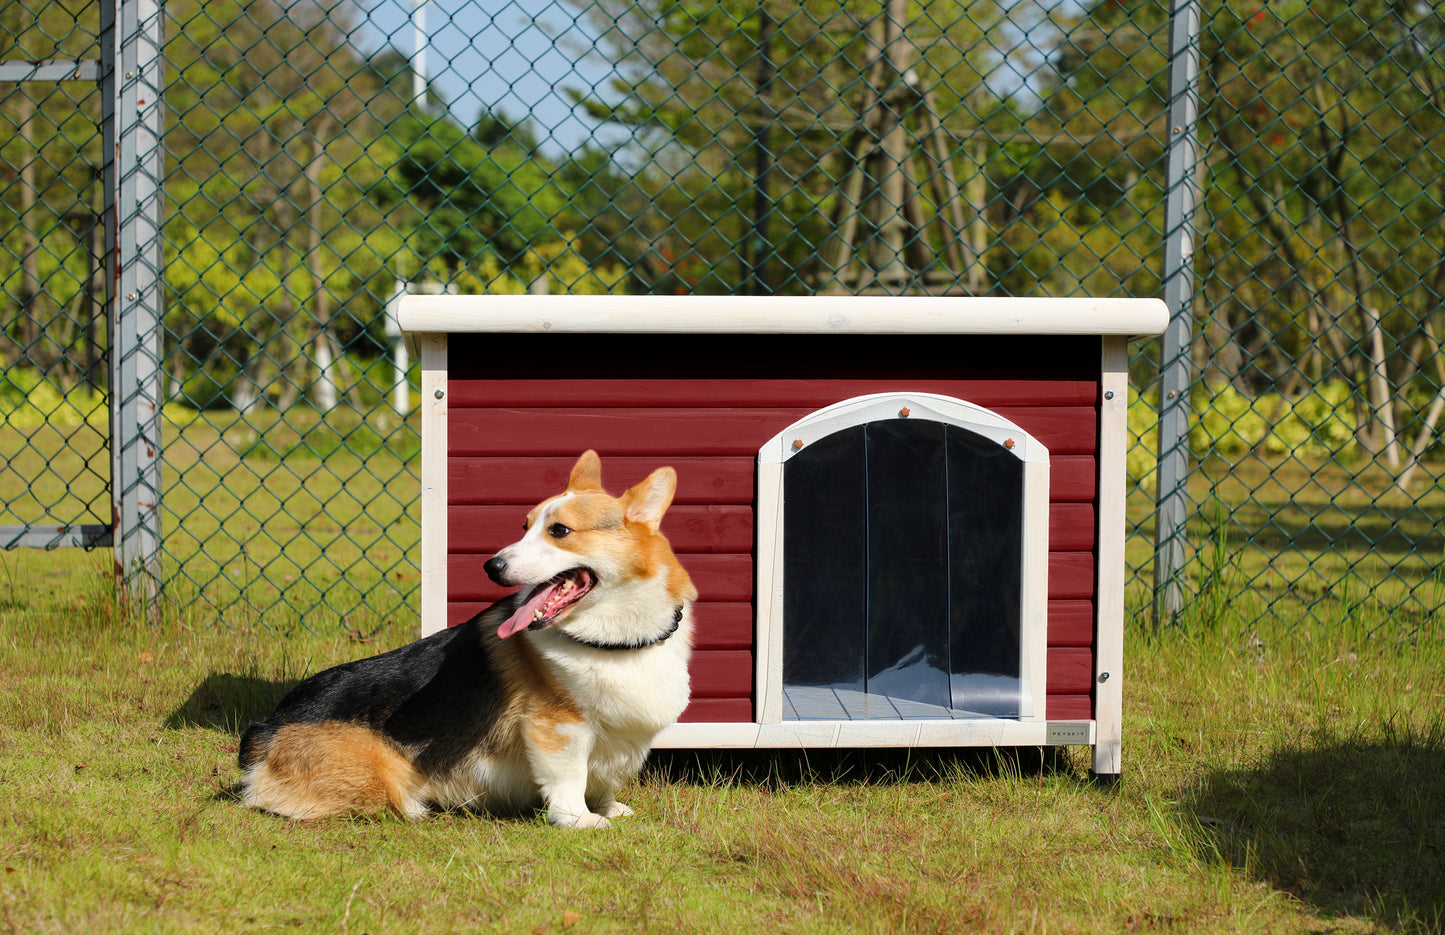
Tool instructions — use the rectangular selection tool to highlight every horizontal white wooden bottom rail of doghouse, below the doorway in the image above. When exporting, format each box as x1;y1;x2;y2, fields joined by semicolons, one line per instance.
652;718;1095;750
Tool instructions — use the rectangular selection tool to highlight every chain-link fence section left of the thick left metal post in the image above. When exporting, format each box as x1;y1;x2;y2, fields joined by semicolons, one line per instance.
0;3;111;546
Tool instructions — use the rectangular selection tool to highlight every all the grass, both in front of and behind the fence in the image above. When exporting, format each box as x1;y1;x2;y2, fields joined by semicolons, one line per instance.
0;419;1445;935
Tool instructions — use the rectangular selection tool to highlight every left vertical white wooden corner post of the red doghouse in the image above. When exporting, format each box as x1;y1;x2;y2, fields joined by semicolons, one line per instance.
418;334;447;636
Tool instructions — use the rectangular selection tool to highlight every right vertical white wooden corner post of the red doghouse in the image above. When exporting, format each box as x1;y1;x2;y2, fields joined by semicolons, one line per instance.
1094;337;1129;776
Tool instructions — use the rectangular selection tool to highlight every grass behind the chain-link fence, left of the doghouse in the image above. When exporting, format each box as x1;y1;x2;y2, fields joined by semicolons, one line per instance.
0;410;419;634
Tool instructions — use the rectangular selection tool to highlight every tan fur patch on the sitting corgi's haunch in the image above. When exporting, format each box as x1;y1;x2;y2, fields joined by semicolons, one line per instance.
246;721;422;819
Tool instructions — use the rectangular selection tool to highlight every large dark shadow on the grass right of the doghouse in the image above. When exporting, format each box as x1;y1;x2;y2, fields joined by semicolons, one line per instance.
1185;727;1445;932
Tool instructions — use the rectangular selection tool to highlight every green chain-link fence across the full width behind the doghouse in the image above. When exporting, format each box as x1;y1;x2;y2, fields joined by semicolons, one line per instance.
0;0;1445;637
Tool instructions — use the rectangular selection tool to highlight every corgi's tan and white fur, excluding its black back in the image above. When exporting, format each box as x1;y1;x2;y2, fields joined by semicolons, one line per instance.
240;451;698;828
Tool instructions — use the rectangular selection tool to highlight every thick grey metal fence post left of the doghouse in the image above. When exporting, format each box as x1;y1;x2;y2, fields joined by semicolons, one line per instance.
101;0;165;617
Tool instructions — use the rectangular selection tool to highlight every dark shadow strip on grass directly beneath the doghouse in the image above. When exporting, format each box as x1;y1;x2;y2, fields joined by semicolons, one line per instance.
642;747;1079;789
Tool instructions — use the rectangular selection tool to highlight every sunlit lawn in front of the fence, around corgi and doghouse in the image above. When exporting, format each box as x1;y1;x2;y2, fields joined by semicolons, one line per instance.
0;552;1445;934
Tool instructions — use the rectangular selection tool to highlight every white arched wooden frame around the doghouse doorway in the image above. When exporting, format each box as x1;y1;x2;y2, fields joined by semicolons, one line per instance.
753;393;1049;728
